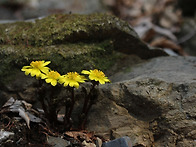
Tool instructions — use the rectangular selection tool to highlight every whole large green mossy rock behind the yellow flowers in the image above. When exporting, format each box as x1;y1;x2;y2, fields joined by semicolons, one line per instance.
0;14;166;85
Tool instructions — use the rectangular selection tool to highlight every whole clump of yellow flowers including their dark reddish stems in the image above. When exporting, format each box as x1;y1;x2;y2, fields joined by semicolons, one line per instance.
21;60;110;130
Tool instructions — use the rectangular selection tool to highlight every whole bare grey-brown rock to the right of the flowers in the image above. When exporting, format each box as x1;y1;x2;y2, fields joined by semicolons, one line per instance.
88;57;196;147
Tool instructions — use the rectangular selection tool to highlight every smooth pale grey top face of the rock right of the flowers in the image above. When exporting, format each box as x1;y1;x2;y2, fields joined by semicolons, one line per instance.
111;56;196;83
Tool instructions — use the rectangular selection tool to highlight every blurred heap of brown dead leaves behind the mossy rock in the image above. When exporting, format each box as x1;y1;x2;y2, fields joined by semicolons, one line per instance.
103;0;187;56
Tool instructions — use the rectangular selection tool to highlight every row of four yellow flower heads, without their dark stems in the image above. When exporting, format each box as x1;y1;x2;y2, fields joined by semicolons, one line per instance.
21;61;110;88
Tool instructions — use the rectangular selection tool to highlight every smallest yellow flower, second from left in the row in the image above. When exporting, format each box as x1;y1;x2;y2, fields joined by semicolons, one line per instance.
41;71;61;86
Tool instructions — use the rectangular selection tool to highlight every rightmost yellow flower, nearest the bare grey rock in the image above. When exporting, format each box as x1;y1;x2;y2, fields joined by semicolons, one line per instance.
82;69;110;84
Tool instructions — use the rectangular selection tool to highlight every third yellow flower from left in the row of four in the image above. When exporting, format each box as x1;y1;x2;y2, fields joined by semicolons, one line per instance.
59;72;87;88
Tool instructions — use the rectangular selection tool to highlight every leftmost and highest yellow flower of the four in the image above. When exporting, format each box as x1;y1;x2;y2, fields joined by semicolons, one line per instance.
21;61;50;78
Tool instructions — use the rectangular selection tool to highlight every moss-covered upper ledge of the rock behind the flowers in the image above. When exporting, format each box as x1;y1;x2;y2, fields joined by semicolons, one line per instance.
0;14;137;46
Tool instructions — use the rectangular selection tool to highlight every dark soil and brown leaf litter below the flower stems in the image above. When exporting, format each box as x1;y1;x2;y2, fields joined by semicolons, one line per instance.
0;112;103;147
